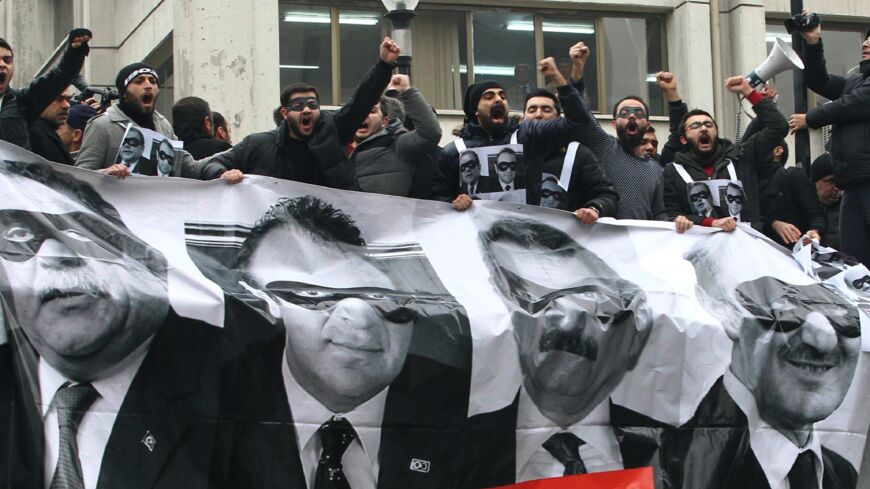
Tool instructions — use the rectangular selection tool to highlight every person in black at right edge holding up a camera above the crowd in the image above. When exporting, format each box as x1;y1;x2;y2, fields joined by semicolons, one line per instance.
789;21;870;266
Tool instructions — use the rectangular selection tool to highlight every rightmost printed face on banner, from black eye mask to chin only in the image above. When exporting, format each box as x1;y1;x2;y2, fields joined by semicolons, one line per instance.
737;277;861;424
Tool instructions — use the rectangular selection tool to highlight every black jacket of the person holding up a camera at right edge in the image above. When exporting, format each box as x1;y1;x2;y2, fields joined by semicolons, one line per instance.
802;40;870;189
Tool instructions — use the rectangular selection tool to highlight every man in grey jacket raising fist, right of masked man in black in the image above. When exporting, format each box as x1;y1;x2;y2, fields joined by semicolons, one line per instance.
350;75;441;197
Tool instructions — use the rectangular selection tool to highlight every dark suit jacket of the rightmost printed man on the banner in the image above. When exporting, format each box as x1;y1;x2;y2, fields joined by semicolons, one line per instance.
662;377;858;489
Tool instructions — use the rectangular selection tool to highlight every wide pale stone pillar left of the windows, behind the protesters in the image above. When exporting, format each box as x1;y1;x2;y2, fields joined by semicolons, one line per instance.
173;0;281;141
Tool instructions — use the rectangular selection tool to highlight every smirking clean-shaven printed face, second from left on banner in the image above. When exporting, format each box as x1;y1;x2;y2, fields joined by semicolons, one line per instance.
240;204;416;412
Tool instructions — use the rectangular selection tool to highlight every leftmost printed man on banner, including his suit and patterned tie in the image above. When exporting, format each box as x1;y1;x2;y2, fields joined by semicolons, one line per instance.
0;161;232;489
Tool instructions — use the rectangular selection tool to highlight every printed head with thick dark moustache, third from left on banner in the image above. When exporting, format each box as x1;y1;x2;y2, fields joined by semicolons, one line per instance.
481;219;650;414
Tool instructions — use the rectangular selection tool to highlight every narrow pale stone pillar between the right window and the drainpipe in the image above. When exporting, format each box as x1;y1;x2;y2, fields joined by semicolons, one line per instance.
667;2;714;113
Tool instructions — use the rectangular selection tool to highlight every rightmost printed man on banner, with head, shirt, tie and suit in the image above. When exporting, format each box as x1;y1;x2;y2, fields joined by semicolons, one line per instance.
664;233;861;489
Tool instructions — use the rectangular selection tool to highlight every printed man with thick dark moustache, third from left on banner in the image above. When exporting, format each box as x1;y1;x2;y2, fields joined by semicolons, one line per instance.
462;218;660;488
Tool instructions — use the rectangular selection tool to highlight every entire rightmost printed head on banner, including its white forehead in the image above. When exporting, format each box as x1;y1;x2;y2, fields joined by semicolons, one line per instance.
687;236;861;432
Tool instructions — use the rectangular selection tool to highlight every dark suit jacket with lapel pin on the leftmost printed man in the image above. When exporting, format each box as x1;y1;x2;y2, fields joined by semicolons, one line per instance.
0;311;232;489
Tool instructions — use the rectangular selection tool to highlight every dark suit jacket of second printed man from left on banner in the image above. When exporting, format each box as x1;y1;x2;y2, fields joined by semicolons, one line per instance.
227;327;469;489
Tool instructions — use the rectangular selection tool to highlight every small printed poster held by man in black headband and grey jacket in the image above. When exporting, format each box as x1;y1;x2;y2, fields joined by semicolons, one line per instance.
115;123;184;177
